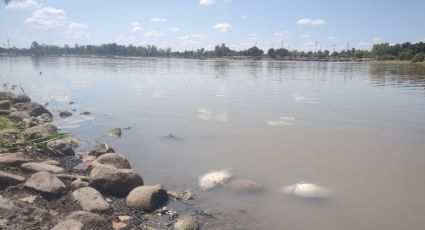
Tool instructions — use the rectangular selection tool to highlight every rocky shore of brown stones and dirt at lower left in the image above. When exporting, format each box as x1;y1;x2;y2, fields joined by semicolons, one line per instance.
0;92;202;230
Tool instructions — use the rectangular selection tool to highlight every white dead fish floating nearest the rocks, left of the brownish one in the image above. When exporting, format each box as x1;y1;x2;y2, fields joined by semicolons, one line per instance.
198;169;232;191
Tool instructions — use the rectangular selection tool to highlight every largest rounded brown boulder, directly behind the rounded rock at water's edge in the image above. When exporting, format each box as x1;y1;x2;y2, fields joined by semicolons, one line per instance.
90;165;143;197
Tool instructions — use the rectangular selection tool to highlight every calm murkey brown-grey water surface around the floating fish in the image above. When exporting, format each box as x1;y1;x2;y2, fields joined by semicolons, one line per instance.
0;57;425;230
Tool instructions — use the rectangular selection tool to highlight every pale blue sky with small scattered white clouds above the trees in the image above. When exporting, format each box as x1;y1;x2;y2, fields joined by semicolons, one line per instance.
0;0;425;51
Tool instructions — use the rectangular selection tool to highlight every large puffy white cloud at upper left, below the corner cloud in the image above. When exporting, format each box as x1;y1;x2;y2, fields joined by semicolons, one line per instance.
24;6;66;30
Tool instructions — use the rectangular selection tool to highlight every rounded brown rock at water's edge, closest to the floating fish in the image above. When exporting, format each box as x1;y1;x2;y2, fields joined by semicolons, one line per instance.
126;185;168;212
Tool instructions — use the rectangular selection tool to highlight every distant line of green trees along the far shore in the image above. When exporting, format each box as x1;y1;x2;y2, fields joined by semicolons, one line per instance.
0;42;425;62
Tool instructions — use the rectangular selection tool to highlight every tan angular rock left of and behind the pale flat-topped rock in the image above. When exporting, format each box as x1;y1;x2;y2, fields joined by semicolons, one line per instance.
25;171;65;197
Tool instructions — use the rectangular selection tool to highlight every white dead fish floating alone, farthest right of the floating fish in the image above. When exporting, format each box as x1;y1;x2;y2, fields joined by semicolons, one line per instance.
281;181;329;199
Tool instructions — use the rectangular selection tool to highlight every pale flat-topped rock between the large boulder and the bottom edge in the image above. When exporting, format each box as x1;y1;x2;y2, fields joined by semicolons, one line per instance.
72;187;111;211
